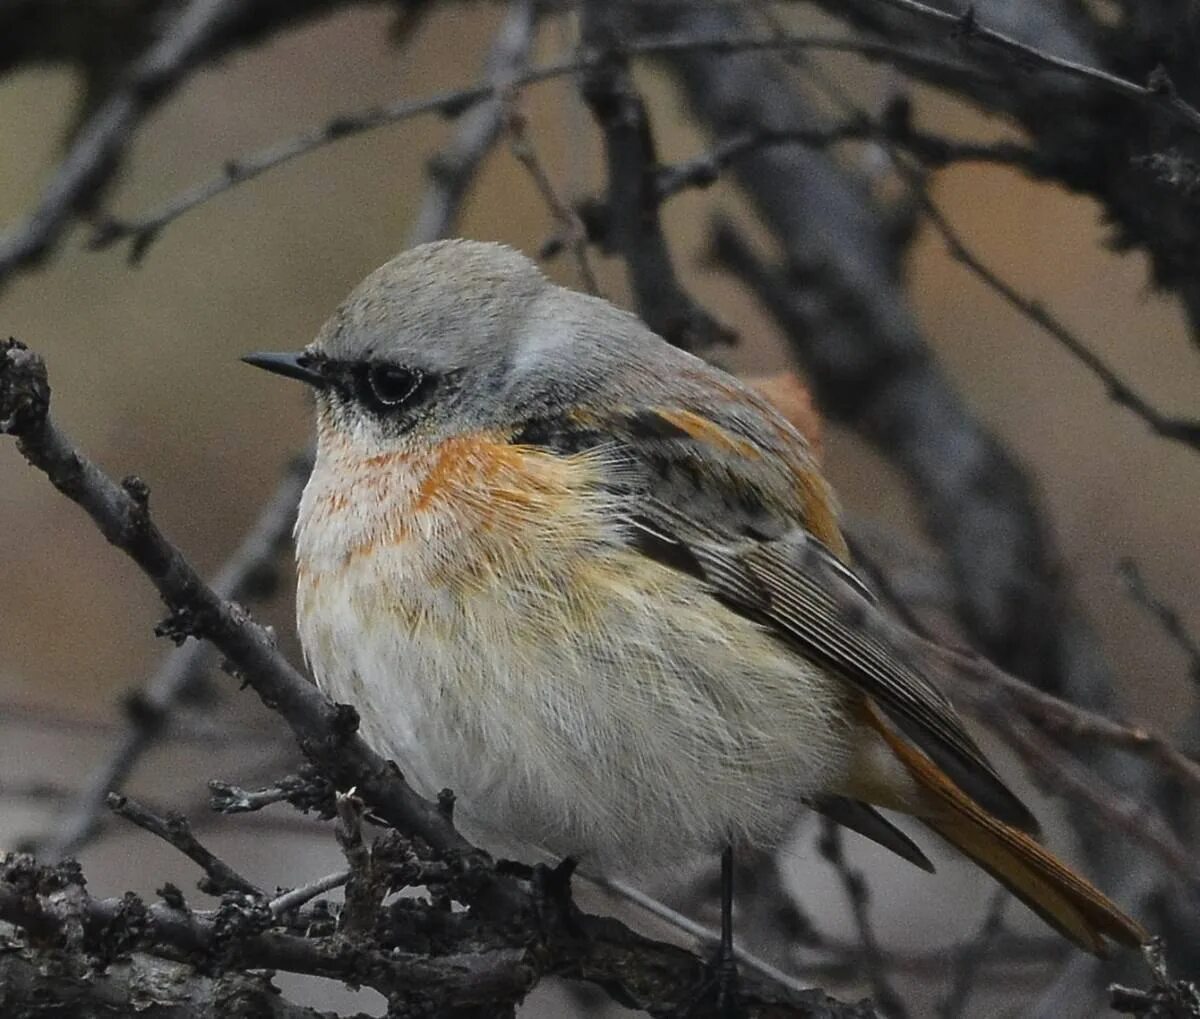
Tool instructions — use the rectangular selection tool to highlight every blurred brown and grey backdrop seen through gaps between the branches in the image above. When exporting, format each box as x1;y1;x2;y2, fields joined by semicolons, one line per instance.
0;5;1200;1017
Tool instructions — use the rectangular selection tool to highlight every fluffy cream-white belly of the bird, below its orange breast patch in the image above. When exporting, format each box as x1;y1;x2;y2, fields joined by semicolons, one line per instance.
298;441;854;871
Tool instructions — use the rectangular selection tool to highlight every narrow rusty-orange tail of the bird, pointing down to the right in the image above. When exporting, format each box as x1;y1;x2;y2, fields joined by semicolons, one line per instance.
871;711;1148;955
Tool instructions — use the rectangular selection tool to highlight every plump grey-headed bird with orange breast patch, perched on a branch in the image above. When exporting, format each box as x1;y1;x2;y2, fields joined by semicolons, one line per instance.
246;240;1146;979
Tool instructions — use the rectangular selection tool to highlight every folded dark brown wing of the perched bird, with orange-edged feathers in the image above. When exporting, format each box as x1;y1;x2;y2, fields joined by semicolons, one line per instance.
512;401;1037;831
